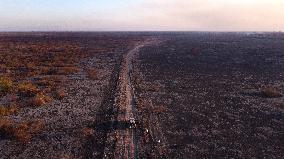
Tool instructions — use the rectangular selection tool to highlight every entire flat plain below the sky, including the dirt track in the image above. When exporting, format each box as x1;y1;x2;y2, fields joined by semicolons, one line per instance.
0;32;284;159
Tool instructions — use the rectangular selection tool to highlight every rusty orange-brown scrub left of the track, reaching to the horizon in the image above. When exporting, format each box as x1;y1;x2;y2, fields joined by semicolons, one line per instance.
0;33;138;145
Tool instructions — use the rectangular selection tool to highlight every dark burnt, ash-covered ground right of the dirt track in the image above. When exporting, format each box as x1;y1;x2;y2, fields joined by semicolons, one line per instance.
134;33;284;159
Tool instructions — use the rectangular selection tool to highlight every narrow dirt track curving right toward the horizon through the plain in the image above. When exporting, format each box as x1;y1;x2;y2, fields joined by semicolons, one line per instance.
104;39;161;159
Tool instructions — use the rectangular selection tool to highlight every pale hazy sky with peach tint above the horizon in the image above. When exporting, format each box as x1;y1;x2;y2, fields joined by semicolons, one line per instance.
0;0;284;31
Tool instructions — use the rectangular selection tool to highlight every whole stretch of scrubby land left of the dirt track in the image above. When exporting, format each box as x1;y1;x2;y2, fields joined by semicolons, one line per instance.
0;33;146;158
